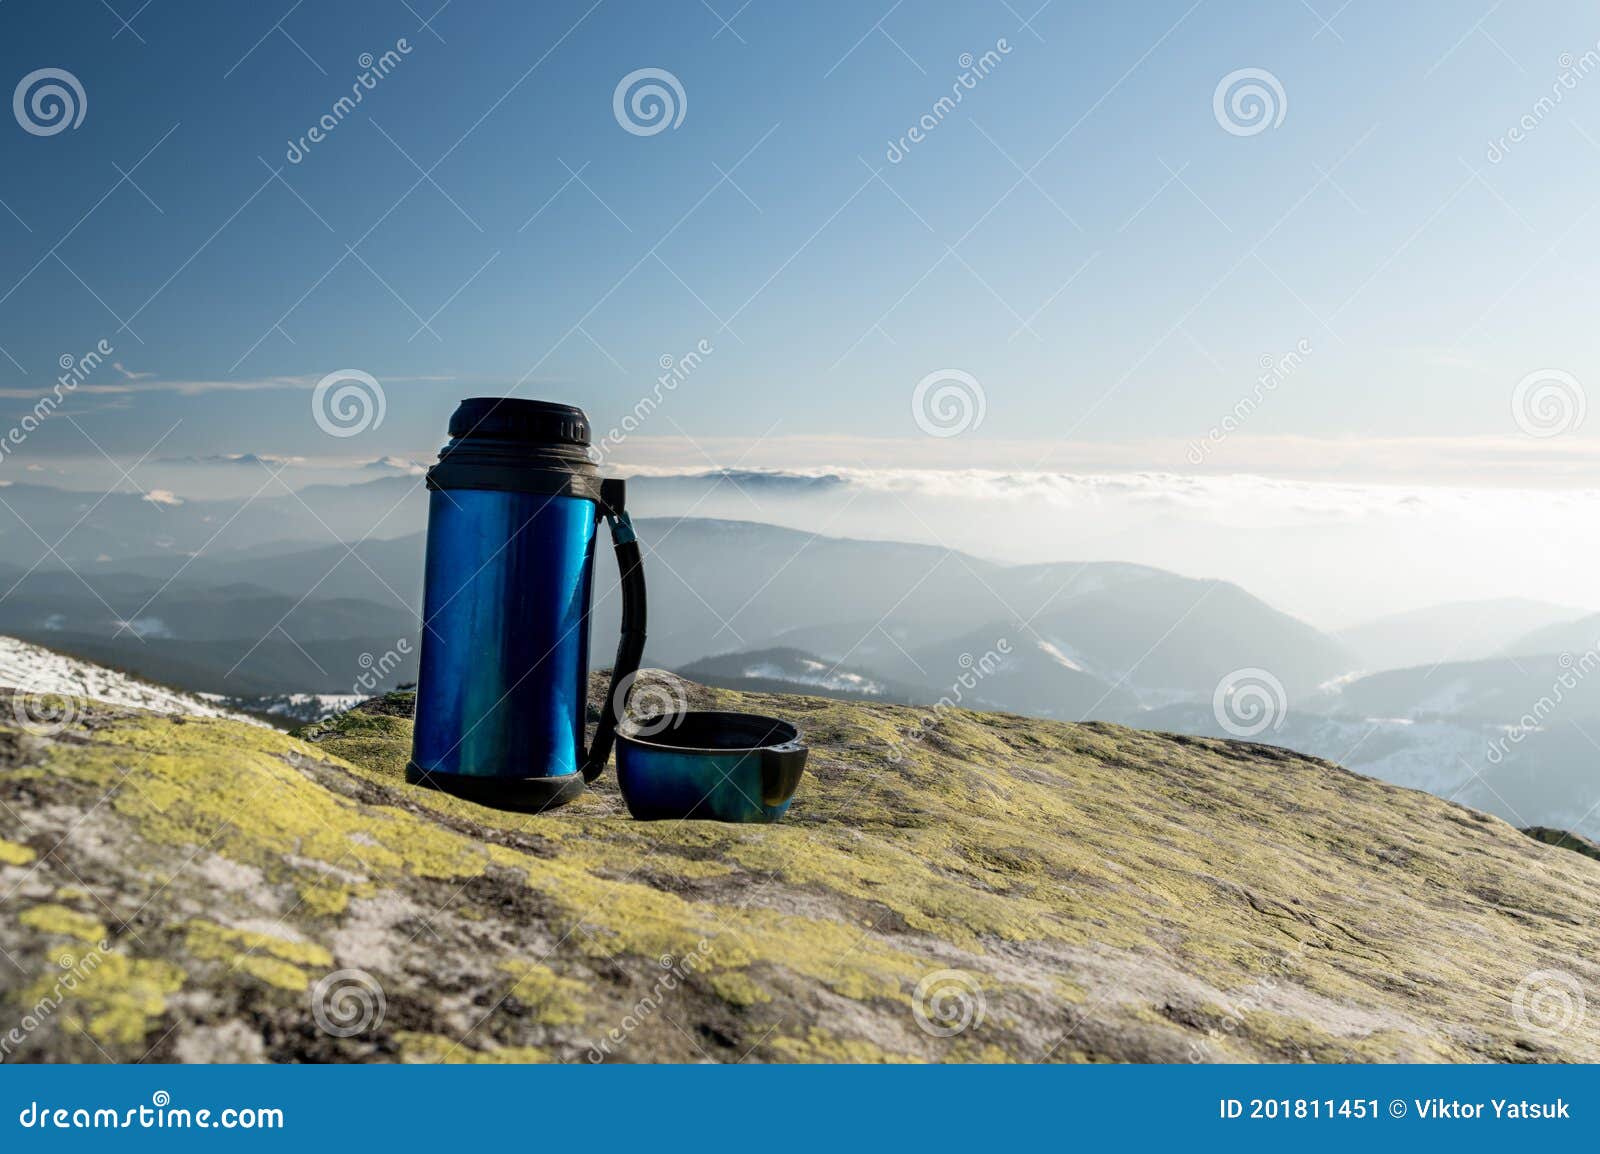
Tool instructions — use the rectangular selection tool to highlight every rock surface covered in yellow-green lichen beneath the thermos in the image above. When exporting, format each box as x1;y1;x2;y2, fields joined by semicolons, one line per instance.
0;675;1600;1061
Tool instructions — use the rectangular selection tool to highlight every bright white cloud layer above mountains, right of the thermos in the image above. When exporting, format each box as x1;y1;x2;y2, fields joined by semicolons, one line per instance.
614;469;1600;627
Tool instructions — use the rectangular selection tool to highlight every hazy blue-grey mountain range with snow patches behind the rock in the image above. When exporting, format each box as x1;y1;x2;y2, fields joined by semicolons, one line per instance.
0;477;1600;834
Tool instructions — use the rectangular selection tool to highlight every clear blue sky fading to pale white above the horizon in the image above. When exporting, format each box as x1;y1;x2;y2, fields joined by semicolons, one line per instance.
0;0;1600;482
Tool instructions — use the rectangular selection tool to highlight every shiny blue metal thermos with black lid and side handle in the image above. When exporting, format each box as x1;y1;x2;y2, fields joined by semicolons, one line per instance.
406;397;645;811
